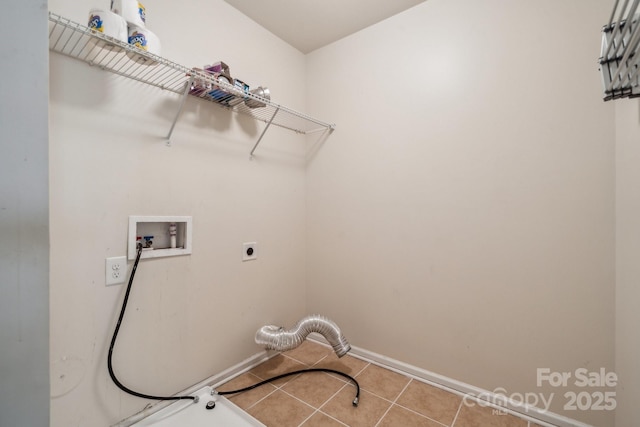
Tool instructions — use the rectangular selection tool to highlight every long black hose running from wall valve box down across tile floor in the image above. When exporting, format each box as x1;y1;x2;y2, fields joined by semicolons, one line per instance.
107;244;360;406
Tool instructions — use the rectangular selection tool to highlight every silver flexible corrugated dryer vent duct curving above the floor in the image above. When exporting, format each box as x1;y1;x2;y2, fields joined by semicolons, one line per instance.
256;315;351;357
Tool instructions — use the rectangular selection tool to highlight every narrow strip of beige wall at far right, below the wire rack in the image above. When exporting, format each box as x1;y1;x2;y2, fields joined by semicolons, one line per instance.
616;99;640;427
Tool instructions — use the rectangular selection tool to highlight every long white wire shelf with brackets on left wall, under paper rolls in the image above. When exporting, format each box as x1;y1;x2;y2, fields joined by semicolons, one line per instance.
49;12;335;156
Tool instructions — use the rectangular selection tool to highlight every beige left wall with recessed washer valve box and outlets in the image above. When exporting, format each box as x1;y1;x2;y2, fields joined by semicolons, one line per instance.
50;0;305;426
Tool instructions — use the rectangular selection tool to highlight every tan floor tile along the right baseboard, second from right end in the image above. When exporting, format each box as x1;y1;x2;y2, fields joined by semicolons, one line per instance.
396;380;462;425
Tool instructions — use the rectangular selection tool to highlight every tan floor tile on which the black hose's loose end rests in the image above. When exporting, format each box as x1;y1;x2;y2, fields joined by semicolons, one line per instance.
320;385;391;427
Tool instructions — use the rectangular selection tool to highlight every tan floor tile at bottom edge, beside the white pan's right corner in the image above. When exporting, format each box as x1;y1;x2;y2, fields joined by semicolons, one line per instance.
247;390;314;427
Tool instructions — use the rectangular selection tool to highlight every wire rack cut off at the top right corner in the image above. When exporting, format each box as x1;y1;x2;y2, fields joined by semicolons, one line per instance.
599;0;640;101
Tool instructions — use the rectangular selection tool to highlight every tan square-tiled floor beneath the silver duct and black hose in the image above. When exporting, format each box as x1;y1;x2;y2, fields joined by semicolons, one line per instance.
218;340;539;427
